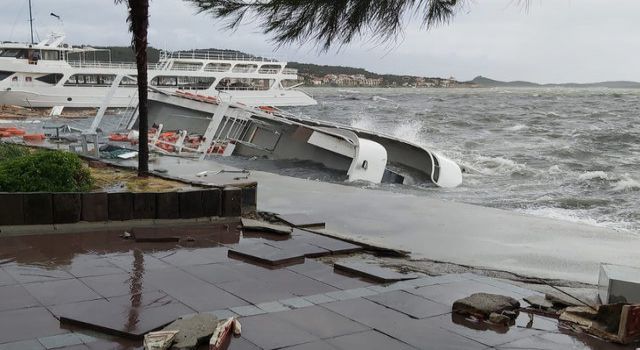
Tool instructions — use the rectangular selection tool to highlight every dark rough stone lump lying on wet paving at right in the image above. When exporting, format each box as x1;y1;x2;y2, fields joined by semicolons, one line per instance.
453;293;520;319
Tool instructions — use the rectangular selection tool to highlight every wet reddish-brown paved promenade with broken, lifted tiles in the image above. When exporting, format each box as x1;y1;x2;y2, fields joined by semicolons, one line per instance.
0;223;635;350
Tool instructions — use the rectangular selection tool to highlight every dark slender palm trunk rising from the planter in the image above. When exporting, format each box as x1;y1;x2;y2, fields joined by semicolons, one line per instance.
129;0;149;177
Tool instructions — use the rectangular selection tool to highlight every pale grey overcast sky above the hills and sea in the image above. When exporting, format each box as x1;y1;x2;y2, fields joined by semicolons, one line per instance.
0;0;640;83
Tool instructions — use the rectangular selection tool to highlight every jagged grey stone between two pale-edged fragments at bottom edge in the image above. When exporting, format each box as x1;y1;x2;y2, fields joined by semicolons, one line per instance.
163;313;218;350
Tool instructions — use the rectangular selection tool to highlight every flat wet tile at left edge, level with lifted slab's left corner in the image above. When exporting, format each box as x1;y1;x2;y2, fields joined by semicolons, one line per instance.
0;307;67;344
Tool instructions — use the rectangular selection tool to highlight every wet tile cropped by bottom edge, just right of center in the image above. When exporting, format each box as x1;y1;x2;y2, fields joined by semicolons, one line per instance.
327;330;414;350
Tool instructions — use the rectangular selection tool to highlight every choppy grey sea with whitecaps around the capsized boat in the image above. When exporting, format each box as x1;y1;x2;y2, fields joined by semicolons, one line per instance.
278;88;640;233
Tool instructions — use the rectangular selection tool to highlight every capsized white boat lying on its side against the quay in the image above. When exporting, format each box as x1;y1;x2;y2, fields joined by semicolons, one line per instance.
117;90;462;187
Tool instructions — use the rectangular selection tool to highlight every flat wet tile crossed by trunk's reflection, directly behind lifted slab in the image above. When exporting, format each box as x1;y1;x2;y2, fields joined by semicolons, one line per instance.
79;273;158;298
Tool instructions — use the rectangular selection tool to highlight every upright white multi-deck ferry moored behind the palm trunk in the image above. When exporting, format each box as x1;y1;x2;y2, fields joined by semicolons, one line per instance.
0;33;317;108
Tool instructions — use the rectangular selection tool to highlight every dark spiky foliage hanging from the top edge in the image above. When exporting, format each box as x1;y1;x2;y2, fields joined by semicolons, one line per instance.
185;0;464;50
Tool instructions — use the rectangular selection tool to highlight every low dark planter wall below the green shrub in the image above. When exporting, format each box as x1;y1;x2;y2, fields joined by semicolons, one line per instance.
0;183;257;226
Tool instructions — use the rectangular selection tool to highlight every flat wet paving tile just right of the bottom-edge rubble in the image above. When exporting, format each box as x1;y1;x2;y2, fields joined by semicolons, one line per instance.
240;314;318;350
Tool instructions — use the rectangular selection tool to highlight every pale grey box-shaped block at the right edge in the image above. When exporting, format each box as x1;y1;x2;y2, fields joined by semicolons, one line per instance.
598;264;640;304
